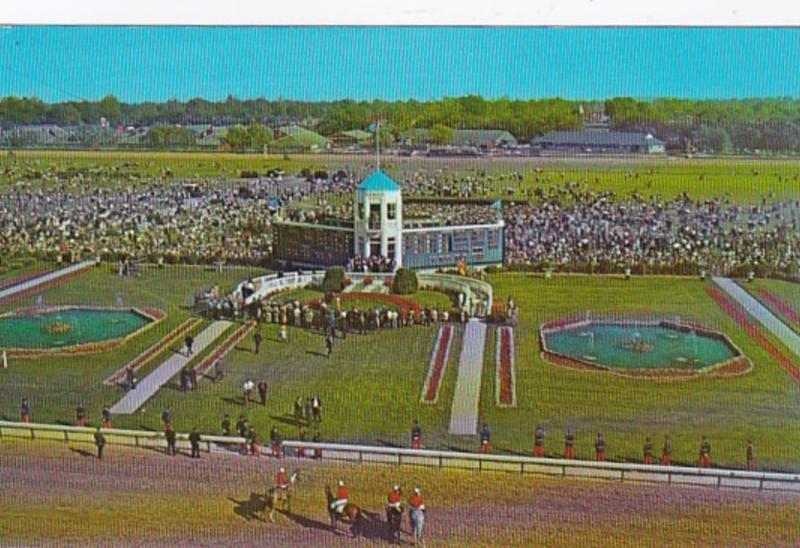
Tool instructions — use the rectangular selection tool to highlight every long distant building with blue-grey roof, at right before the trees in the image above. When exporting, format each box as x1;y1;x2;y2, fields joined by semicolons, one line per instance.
531;129;665;154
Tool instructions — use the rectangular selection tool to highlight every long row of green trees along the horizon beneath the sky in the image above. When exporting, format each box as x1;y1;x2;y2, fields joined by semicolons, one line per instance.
0;95;800;153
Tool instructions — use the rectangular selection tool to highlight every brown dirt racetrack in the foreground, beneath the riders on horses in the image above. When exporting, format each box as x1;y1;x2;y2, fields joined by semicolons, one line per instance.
0;441;800;546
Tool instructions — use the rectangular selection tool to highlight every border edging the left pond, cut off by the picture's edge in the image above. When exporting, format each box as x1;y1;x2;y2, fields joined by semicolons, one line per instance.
0;305;167;358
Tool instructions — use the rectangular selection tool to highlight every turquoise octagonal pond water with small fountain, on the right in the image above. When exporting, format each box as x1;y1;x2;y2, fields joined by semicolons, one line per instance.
544;323;738;369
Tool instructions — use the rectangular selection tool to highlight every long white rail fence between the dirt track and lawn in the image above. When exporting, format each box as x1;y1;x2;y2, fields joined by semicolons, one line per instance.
0;421;800;494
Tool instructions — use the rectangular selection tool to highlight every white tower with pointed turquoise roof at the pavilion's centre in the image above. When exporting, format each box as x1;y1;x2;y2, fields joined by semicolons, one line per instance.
353;171;403;268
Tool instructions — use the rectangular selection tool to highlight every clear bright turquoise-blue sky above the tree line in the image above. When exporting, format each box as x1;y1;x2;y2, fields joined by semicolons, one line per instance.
0;26;800;102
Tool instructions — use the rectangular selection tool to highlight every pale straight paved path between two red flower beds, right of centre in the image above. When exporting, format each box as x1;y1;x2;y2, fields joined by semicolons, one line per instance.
450;319;486;436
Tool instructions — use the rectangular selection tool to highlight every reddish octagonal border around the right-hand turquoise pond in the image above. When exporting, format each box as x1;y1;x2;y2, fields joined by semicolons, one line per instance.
539;318;753;381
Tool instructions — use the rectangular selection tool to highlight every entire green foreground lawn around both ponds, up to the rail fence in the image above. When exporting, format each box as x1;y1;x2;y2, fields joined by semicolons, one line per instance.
0;267;800;470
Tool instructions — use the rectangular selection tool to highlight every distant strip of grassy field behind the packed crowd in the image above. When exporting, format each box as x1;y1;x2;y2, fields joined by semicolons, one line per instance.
0;151;800;203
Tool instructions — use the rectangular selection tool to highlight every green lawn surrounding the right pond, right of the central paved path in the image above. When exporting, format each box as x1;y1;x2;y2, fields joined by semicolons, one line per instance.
481;274;800;469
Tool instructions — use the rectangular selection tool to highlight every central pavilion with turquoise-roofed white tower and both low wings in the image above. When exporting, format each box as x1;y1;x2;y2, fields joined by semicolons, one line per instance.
273;171;505;269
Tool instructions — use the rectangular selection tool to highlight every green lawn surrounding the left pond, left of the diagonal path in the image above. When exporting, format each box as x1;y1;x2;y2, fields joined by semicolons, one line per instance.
0;265;262;427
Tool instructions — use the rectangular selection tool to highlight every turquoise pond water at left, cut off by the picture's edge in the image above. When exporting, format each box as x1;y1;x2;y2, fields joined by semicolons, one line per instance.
0;308;152;349
